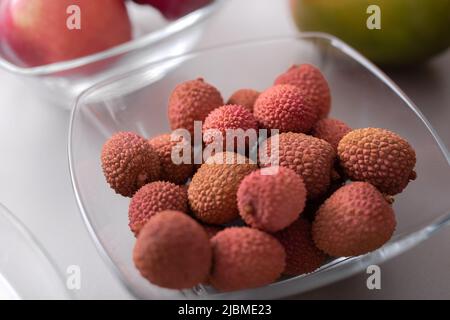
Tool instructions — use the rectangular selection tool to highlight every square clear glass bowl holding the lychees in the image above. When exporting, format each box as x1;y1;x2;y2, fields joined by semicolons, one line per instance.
68;33;450;299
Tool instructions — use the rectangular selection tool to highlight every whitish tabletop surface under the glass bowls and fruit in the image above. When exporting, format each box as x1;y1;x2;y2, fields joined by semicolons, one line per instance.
0;0;450;299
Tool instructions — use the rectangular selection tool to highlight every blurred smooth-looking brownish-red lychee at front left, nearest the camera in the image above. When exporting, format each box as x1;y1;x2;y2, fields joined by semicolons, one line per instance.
133;211;212;289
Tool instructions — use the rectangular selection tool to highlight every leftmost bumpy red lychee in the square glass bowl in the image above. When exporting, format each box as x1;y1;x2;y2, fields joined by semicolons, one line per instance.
101;132;160;197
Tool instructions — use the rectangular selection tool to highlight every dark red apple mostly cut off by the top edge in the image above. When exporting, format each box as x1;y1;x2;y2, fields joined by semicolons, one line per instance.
133;0;212;20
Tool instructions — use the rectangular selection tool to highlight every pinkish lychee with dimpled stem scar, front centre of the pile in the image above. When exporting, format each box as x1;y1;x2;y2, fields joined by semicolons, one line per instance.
237;167;306;232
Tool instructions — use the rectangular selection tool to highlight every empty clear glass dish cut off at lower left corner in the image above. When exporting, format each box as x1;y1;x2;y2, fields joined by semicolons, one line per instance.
0;204;72;300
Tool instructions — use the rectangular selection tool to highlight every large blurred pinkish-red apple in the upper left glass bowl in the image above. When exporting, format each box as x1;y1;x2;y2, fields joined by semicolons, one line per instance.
0;0;131;67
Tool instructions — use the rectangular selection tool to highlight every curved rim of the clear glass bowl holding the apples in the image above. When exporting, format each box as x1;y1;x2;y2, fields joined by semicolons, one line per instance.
0;0;225;76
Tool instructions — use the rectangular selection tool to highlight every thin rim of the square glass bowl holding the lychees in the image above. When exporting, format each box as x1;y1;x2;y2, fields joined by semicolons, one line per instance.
68;32;450;299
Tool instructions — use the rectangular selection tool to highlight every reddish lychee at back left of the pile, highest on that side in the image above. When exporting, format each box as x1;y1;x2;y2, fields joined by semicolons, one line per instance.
169;78;223;135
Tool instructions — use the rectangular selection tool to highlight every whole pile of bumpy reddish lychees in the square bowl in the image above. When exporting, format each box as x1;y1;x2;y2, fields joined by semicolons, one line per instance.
101;64;416;291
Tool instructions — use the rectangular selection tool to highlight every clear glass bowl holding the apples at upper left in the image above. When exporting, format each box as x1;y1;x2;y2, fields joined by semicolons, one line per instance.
0;0;224;108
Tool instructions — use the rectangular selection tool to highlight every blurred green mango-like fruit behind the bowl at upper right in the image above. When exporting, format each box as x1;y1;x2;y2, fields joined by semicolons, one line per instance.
291;0;450;65
